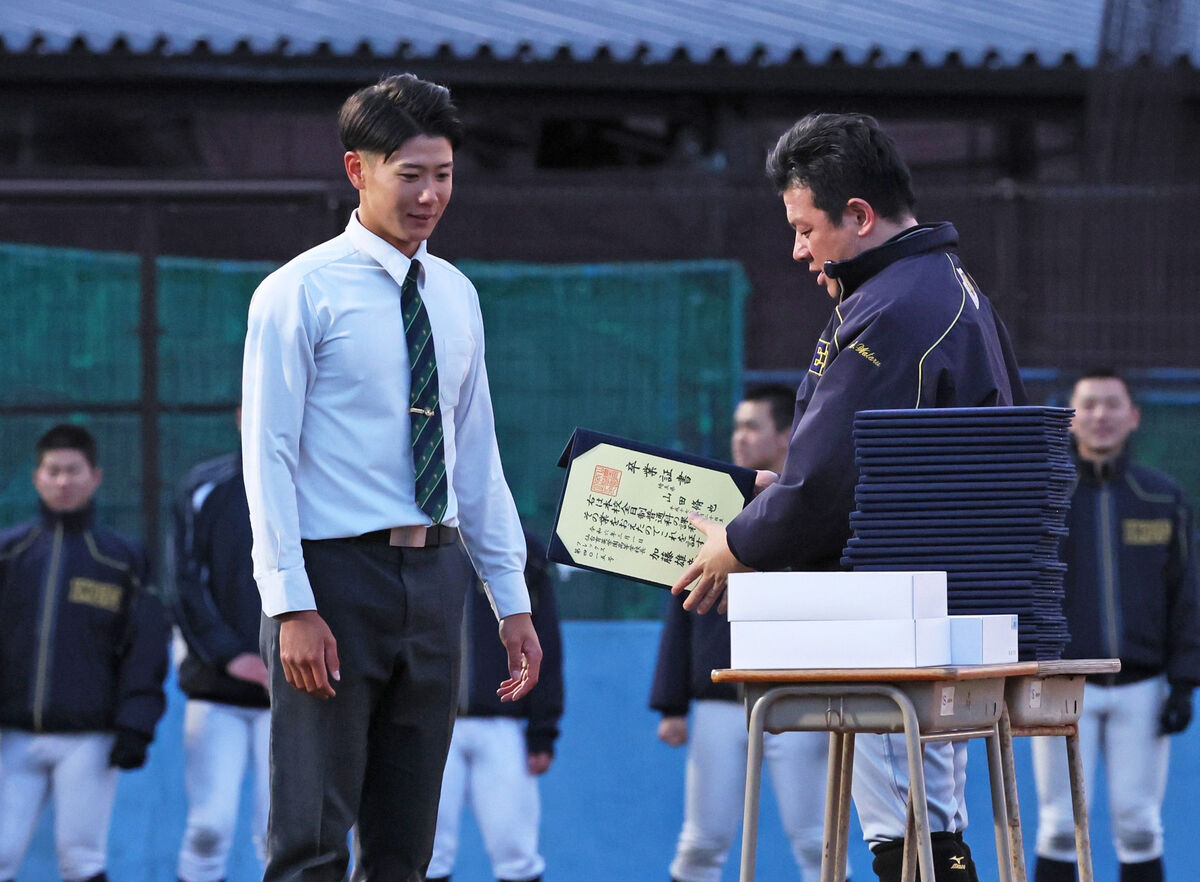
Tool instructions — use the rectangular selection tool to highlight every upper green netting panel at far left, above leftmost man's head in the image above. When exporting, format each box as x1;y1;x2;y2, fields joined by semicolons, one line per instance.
0;244;140;406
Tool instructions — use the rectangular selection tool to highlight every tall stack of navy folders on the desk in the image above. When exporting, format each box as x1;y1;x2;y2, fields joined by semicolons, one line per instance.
842;407;1075;661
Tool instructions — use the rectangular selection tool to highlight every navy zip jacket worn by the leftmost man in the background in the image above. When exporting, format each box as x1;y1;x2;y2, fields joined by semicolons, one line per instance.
0;506;167;738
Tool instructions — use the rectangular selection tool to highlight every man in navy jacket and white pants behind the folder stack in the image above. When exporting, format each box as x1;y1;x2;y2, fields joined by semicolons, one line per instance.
1033;368;1200;882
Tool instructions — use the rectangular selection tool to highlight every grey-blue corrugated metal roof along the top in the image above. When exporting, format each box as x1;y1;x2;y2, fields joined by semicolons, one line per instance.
0;0;1198;66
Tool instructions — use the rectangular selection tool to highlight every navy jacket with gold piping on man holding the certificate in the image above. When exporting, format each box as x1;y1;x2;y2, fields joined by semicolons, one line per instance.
727;223;1025;570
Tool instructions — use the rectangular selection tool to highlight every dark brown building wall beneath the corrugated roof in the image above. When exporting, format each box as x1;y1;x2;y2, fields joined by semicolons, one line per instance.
0;50;1200;371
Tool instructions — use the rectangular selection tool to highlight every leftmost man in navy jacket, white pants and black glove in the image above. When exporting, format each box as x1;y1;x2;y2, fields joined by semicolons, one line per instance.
0;425;167;882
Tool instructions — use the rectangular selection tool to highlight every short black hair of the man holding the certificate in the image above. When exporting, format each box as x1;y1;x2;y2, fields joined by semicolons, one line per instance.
767;113;917;223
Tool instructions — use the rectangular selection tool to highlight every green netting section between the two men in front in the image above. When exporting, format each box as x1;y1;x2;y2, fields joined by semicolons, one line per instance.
460;260;749;618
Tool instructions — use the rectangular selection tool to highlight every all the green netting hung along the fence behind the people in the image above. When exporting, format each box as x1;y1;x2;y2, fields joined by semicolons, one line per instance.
0;246;749;618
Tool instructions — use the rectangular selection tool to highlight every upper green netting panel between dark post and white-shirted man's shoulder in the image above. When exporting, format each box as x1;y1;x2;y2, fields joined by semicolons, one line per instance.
158;257;276;406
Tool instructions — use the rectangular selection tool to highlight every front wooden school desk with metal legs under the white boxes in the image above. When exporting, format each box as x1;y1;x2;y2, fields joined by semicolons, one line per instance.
712;661;1038;882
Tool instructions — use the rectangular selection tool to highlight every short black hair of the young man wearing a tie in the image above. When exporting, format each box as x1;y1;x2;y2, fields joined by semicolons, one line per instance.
337;73;463;160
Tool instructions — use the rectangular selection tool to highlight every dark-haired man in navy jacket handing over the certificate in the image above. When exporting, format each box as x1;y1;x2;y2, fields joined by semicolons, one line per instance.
672;114;1025;882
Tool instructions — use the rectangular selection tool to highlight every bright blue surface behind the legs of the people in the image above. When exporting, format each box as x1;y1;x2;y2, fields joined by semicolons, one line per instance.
9;619;1200;882
